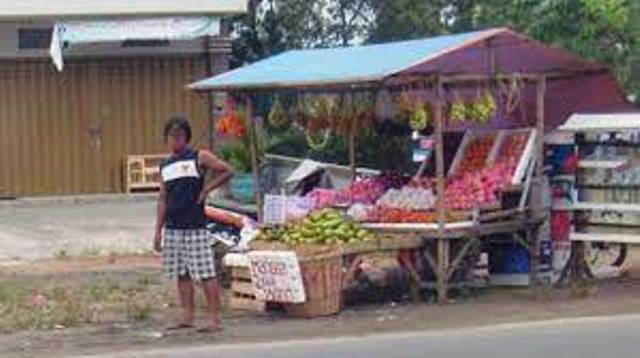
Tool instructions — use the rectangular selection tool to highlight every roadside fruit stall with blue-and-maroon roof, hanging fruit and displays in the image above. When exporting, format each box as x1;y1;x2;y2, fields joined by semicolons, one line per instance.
190;29;632;316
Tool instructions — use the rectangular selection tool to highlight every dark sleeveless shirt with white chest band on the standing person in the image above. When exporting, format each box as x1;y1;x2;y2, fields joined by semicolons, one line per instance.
160;149;206;230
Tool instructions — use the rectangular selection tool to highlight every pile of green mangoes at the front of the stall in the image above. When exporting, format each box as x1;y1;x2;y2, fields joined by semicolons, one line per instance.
256;209;372;246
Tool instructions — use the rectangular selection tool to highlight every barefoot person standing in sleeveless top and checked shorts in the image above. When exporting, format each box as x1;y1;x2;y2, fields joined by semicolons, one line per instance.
153;116;233;332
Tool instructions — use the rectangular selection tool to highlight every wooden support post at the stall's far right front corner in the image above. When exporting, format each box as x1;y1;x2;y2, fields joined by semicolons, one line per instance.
529;77;549;293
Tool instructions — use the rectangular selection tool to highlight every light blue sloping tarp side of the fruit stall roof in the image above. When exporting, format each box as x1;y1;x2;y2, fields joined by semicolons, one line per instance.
189;29;505;90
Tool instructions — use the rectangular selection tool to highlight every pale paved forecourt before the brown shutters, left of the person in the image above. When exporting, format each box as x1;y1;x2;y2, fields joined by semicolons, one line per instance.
0;197;155;265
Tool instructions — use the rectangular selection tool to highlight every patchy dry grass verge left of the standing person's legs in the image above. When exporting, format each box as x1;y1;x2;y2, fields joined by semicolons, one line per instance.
0;273;175;333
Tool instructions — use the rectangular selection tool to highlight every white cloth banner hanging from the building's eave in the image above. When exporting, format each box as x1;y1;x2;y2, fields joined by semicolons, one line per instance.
50;17;220;71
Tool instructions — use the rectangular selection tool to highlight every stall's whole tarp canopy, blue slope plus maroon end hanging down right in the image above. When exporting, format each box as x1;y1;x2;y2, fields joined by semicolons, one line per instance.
188;28;631;129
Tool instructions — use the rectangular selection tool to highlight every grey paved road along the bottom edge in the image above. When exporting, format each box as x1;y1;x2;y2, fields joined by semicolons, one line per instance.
82;315;640;358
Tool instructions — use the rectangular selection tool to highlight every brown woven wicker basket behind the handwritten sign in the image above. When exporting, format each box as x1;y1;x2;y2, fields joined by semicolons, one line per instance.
284;252;342;318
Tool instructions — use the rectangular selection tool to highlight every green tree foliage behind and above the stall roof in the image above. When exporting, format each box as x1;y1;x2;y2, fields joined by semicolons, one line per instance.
233;0;640;101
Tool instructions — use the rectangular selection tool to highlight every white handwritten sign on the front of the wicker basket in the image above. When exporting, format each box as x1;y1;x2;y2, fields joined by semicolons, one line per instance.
248;251;306;303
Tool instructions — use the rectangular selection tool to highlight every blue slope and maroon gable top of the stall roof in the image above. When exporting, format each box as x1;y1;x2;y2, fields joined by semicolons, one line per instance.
190;28;602;91
